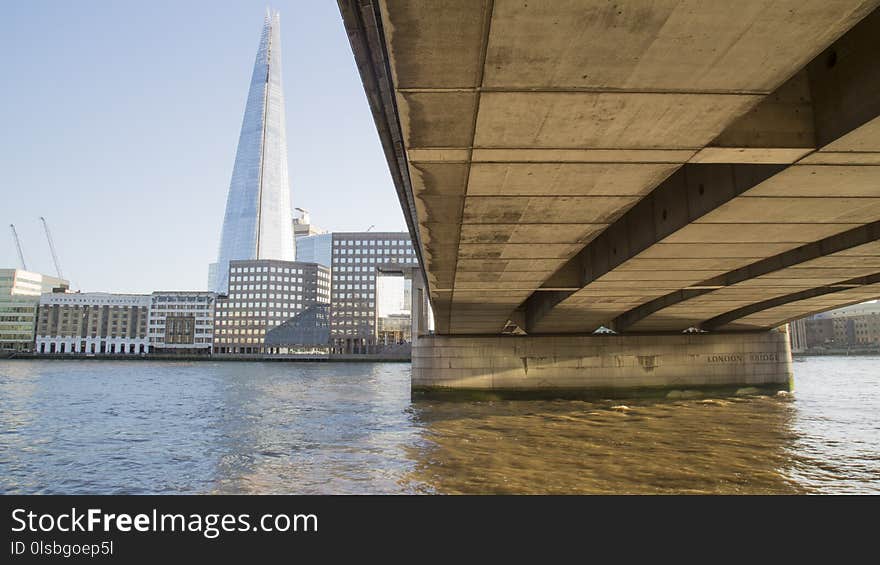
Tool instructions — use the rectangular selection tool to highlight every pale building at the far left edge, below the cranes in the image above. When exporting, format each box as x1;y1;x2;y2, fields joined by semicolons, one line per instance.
0;269;69;353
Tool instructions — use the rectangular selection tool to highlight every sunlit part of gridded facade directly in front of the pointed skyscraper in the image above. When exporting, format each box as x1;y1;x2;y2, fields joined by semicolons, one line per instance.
214;259;330;355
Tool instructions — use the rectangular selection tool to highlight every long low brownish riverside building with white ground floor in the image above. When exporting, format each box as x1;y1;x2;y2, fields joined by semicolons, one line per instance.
36;292;150;355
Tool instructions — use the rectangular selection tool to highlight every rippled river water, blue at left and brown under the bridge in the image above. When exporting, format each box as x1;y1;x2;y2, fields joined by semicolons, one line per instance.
0;357;880;494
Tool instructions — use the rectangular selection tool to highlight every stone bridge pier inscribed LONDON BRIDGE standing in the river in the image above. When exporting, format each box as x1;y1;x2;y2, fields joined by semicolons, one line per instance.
412;330;792;398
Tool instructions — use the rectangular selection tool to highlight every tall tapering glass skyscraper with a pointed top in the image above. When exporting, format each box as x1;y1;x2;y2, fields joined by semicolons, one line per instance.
208;12;296;293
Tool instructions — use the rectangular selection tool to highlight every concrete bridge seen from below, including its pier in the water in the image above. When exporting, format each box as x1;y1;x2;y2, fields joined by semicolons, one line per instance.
339;0;880;392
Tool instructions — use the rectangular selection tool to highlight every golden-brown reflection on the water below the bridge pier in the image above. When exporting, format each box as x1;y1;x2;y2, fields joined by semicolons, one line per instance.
411;397;803;493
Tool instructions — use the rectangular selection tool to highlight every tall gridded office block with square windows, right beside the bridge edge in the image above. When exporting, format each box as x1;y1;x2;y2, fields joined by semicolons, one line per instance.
330;232;417;353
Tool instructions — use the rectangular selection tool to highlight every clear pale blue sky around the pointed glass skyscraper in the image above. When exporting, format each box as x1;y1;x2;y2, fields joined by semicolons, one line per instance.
0;0;406;292
